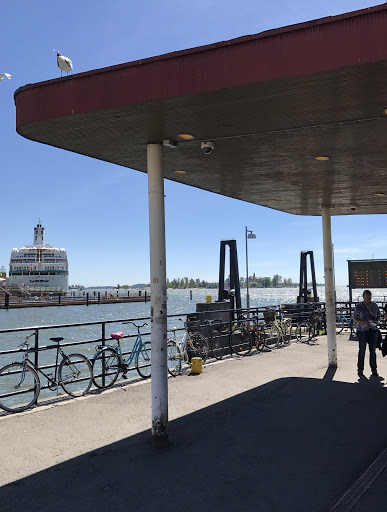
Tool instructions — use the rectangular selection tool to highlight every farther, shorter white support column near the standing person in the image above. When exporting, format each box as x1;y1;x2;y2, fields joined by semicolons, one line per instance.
321;207;337;367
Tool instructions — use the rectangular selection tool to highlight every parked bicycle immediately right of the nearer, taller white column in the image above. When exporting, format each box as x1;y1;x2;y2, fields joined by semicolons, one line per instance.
167;318;209;377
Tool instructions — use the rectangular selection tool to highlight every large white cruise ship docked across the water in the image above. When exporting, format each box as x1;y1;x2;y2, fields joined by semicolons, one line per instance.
7;220;69;293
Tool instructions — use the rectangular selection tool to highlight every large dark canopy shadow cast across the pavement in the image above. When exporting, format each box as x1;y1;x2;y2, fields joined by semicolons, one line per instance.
0;378;387;512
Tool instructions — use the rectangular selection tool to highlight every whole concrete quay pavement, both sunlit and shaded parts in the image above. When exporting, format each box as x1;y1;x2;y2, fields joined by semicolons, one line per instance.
0;333;387;512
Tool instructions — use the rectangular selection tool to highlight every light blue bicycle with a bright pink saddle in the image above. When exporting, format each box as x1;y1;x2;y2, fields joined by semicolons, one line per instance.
92;322;151;389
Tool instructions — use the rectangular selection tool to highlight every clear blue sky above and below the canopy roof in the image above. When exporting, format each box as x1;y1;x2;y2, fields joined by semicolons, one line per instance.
0;0;387;286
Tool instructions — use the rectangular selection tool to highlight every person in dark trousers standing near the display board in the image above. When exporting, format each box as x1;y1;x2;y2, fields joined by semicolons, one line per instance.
353;290;380;377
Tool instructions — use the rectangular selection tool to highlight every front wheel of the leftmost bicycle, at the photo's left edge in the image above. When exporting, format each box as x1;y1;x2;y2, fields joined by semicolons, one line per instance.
0;363;40;412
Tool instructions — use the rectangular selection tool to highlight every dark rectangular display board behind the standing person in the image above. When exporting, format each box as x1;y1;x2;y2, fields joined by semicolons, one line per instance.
348;260;387;289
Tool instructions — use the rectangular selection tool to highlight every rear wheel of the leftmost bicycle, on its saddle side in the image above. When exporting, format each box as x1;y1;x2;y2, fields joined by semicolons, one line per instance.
58;353;93;397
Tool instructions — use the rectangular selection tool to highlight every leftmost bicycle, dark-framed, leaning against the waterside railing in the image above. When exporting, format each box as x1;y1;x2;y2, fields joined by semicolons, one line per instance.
0;332;92;412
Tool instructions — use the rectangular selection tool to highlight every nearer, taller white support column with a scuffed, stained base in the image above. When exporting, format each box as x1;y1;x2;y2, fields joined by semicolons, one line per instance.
147;144;168;446
